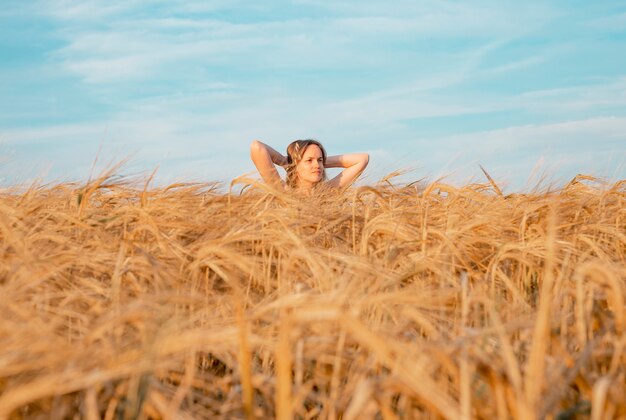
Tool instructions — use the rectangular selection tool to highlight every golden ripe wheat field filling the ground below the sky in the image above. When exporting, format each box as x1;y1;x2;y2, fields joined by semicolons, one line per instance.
0;171;626;420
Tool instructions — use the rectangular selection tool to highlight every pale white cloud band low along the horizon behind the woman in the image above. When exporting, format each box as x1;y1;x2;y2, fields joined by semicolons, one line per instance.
0;101;626;191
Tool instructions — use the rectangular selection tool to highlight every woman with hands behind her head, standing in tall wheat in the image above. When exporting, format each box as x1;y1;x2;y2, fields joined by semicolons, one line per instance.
250;139;369;194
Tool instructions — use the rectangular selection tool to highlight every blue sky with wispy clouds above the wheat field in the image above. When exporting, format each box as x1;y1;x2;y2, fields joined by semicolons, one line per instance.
0;0;626;191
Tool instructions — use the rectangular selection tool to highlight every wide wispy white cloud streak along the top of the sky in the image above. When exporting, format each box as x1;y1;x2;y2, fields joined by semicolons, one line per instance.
40;0;550;83
